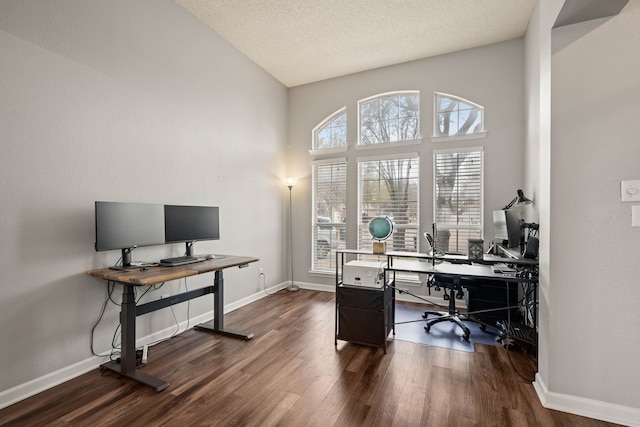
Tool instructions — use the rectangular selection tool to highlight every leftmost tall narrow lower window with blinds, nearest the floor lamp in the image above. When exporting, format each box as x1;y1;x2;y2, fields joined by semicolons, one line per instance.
311;159;347;272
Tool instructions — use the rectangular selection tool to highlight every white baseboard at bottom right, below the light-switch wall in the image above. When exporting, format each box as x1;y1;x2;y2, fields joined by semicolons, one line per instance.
533;374;640;427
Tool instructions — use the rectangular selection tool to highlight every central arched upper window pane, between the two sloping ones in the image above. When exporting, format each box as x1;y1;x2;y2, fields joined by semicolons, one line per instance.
358;91;420;145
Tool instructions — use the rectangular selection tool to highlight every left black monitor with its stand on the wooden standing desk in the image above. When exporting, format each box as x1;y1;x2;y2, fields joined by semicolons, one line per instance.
95;201;165;269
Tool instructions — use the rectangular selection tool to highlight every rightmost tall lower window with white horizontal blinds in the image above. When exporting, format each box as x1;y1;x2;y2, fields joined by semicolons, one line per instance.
433;148;483;253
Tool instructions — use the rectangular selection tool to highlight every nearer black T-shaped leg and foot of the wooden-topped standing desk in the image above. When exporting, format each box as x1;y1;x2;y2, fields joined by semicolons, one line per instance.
101;284;169;391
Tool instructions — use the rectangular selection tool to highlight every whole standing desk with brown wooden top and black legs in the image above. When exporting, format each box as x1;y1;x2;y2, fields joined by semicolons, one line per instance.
86;255;259;391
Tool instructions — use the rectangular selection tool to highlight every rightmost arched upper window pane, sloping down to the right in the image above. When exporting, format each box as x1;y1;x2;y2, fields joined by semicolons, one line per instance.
433;92;486;138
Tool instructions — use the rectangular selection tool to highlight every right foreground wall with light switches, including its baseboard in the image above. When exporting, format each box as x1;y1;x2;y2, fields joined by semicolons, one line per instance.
527;0;640;425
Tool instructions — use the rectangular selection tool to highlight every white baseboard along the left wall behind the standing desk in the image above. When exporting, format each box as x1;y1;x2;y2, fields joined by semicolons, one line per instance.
0;283;286;409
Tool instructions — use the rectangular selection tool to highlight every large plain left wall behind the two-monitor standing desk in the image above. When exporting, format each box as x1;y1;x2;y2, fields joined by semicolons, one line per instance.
0;0;287;402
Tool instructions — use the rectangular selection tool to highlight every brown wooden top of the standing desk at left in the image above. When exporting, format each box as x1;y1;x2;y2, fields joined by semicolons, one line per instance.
86;255;260;286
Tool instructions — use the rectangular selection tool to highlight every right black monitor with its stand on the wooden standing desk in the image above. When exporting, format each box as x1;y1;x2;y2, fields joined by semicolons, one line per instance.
164;205;220;256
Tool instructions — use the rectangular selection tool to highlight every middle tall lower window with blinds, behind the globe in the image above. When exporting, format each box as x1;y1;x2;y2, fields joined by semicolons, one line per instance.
358;154;419;251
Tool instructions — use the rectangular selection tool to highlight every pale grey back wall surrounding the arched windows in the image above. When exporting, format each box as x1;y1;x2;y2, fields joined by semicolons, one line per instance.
289;39;526;293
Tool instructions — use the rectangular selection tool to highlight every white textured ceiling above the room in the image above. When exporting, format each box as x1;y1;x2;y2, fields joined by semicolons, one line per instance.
176;0;535;87
